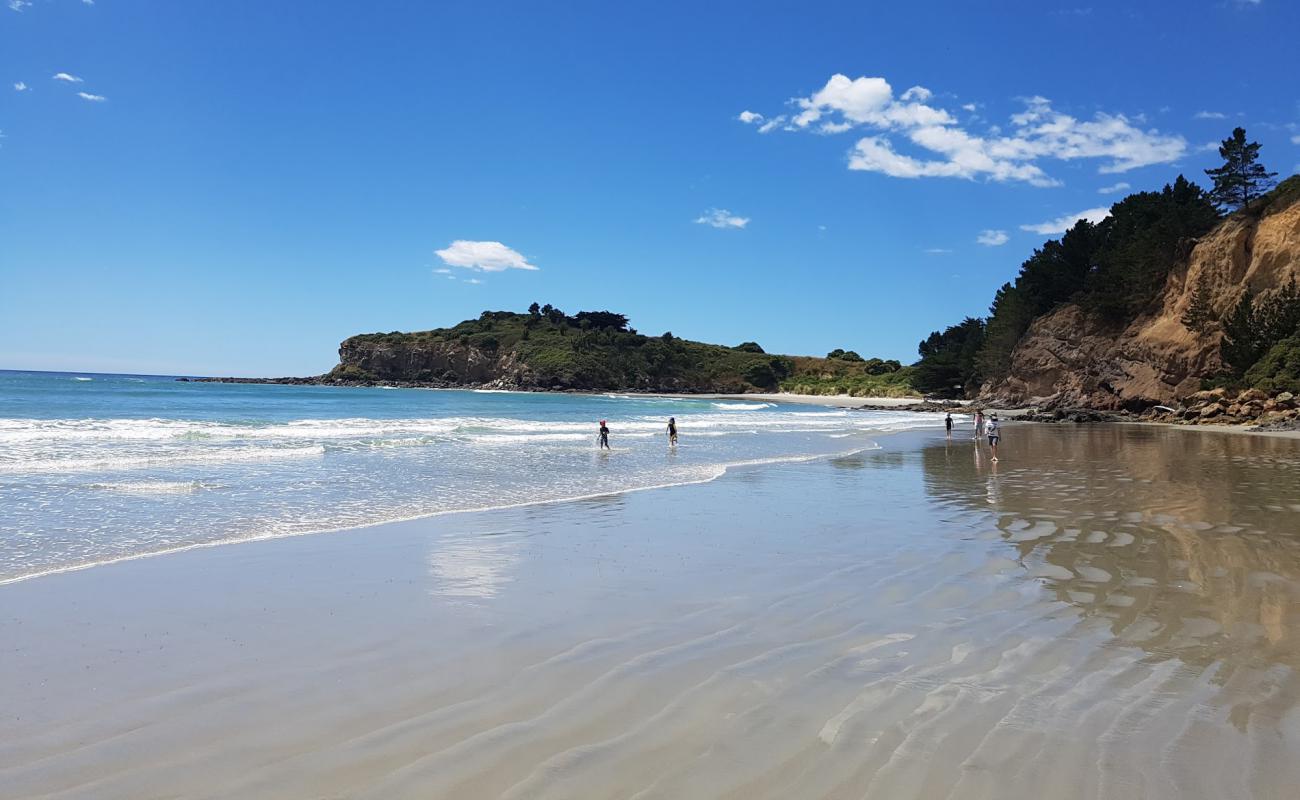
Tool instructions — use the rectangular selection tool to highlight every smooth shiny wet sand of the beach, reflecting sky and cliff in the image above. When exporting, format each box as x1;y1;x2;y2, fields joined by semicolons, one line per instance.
0;425;1300;800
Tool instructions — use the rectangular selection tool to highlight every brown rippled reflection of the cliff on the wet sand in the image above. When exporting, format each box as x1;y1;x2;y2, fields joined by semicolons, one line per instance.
922;425;1300;680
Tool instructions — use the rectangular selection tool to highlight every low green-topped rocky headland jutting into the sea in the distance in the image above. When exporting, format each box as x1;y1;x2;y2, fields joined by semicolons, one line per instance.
326;303;915;397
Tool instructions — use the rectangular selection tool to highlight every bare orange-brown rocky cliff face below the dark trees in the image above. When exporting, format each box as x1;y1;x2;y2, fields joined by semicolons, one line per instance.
982;195;1300;410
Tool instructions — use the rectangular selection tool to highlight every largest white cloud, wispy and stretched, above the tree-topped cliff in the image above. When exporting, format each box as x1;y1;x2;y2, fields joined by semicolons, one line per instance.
745;74;1187;186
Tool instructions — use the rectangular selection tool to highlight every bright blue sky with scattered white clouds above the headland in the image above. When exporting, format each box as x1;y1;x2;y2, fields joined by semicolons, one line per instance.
0;0;1300;375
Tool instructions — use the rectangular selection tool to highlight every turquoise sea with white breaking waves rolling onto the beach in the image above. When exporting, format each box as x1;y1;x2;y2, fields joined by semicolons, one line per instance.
0;371;941;581
